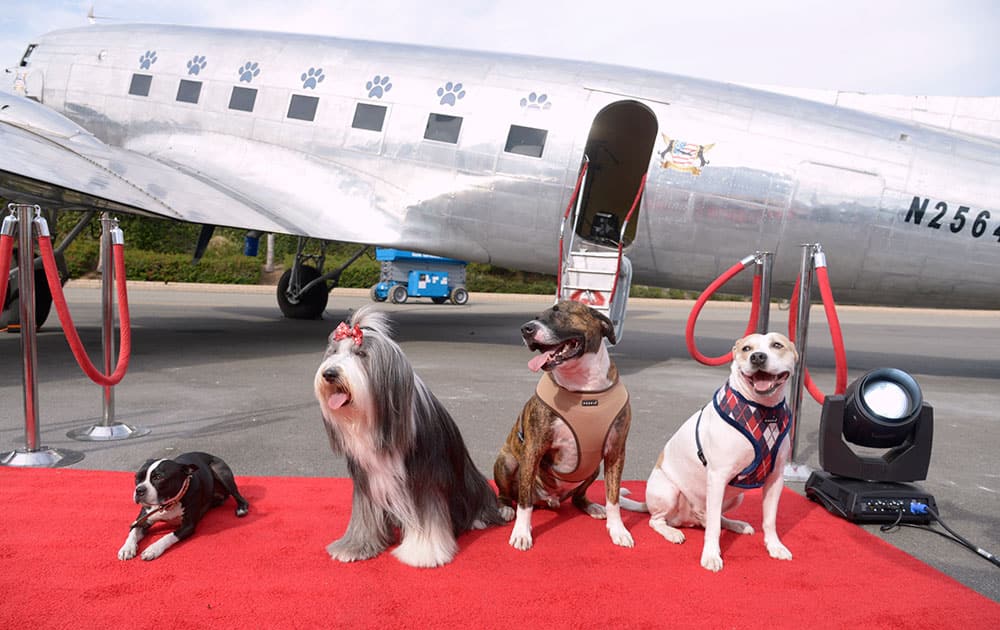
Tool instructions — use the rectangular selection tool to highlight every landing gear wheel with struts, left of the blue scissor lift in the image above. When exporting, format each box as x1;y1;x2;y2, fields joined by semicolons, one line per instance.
277;236;368;319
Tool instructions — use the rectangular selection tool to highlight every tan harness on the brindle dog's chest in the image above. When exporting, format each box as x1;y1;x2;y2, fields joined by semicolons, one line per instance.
535;373;628;482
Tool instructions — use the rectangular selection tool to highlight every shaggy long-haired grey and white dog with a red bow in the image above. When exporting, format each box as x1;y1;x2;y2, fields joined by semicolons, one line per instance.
315;306;503;566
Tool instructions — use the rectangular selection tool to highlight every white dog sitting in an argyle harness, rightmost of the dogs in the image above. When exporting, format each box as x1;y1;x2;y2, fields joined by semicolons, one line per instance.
622;333;798;571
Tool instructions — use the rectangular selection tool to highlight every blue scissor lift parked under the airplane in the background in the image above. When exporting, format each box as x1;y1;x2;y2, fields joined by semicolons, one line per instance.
371;247;469;305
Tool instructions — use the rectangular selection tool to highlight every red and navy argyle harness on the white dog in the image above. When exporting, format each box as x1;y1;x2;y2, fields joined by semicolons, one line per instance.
694;381;792;488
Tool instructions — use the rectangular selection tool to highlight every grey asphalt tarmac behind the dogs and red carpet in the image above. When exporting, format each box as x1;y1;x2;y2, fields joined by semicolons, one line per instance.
0;281;1000;602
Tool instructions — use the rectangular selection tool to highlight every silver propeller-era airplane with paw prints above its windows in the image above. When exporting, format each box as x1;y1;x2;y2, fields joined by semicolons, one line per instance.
0;25;1000;326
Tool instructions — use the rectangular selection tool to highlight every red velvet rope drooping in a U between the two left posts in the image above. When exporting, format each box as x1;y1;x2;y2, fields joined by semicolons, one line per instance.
38;236;132;387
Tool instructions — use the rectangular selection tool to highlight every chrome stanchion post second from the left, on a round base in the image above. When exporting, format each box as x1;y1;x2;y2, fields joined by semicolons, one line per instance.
66;212;149;442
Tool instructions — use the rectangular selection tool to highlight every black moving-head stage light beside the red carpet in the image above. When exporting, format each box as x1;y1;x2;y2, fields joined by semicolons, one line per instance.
805;368;937;523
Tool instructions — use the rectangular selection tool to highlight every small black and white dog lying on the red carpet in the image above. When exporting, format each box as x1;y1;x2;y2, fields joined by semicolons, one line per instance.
118;453;250;560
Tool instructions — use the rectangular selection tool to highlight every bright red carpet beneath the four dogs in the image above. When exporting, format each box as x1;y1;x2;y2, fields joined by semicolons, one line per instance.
0;468;1000;630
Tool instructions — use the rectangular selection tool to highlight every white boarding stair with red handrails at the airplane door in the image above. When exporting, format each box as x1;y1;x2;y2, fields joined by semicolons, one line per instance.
556;157;646;343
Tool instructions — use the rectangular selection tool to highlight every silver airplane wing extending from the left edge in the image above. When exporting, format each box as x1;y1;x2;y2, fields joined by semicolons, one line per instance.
0;92;306;234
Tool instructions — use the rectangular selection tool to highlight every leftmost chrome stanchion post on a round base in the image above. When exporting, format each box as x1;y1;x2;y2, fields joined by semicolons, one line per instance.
0;204;83;467
